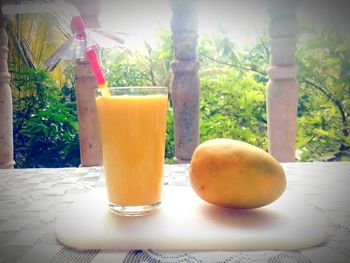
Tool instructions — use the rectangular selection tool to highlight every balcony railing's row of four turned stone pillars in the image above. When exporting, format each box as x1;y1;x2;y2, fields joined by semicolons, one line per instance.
0;0;298;168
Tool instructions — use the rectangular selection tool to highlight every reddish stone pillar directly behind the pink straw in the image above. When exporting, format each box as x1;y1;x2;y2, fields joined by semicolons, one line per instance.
67;0;102;166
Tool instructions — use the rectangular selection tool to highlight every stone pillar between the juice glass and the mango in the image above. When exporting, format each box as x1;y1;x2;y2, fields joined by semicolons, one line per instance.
170;0;200;163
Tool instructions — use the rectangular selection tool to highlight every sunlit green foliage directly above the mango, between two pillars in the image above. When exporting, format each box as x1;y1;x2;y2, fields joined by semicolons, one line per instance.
198;30;267;149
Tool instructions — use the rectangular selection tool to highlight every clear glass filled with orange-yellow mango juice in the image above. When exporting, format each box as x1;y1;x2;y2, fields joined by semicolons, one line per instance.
96;87;168;215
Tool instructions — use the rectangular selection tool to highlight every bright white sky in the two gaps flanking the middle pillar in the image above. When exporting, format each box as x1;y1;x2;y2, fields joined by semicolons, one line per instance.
100;0;268;47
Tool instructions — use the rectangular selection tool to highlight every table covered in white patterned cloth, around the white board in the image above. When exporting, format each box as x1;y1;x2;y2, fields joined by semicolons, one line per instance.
0;162;350;263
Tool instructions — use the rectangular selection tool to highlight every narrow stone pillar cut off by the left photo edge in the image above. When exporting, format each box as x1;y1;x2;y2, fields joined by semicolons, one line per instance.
0;13;14;169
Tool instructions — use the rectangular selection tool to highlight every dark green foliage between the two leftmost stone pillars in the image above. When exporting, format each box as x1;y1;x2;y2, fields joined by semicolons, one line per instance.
11;70;80;168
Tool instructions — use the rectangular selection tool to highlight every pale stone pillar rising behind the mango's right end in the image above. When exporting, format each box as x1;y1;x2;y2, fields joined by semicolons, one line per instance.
267;0;298;162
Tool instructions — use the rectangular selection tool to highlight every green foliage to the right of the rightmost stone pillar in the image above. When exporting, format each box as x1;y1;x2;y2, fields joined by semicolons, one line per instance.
297;27;350;161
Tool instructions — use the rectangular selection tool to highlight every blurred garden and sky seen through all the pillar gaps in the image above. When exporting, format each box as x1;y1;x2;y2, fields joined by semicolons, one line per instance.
3;0;350;167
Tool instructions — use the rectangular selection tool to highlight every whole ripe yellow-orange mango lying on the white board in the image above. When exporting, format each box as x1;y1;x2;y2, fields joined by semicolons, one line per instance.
189;138;286;209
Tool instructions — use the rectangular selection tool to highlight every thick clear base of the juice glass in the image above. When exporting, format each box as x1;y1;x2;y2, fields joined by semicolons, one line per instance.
109;201;161;216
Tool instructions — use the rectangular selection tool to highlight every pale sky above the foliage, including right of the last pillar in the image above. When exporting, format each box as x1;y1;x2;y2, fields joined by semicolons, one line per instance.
100;0;350;48
